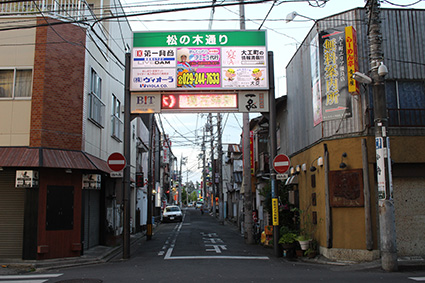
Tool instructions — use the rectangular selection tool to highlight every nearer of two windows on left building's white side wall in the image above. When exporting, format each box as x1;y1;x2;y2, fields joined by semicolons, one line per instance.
89;69;105;128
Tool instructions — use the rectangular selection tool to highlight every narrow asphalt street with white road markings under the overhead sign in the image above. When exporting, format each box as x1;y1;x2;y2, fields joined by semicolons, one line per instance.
0;208;425;283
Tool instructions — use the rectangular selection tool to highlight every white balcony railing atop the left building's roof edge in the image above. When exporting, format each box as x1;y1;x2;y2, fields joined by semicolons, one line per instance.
0;0;91;21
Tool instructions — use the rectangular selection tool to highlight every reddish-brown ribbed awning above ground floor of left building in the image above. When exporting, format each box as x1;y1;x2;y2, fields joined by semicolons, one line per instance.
0;147;111;173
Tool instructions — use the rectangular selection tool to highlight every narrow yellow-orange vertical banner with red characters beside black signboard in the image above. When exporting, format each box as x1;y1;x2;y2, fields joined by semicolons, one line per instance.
345;26;360;94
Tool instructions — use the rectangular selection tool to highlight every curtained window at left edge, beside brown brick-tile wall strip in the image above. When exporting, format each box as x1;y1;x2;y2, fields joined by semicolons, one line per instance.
0;69;32;98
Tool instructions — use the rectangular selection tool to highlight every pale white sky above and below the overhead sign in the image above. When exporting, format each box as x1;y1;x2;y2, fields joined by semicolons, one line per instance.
122;0;425;183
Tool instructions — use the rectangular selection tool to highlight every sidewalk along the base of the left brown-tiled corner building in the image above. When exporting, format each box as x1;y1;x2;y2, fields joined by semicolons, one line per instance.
0;232;146;275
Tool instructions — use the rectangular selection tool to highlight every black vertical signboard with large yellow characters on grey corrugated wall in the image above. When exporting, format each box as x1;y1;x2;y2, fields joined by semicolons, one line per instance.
317;27;352;121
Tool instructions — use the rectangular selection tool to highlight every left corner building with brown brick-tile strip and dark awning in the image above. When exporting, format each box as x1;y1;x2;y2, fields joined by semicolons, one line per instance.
0;1;137;259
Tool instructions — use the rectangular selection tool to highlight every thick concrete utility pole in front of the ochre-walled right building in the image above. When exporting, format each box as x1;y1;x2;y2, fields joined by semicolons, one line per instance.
367;0;398;271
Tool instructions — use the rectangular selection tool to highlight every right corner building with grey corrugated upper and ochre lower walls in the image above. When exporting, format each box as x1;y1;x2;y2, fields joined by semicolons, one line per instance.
277;8;425;260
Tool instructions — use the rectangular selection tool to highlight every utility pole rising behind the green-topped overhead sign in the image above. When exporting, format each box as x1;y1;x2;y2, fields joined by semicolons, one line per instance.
239;0;254;244
